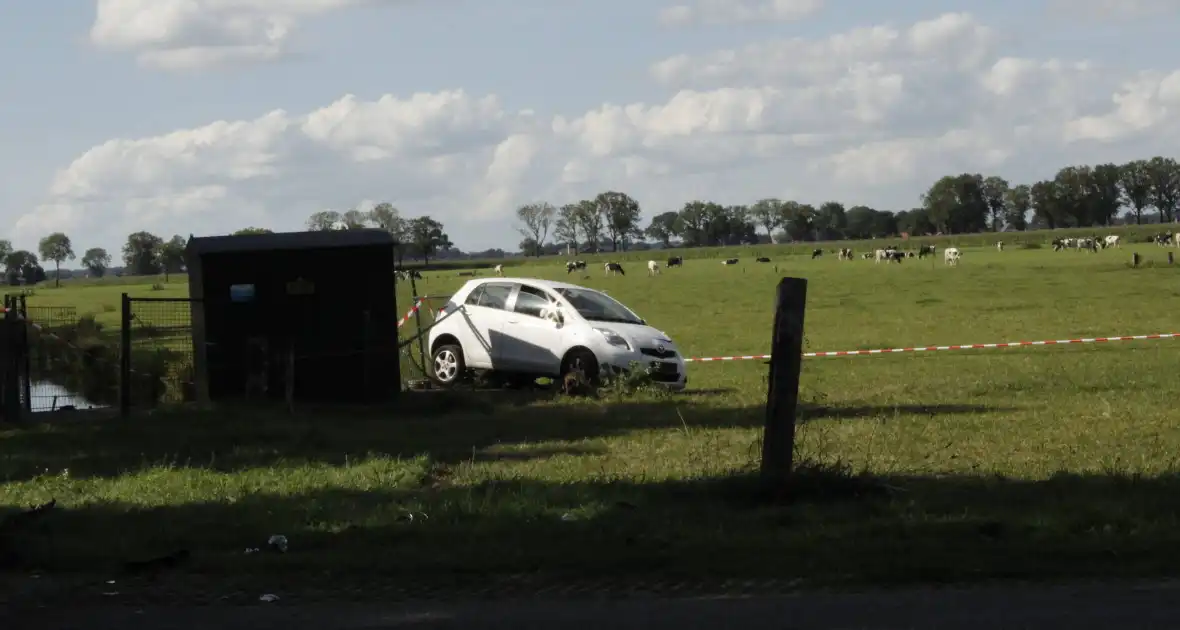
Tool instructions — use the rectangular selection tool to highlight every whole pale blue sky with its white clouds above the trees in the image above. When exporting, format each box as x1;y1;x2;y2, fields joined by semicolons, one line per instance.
0;0;1180;254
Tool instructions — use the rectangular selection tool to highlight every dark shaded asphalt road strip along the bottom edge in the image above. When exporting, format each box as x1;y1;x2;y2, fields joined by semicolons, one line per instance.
13;583;1180;630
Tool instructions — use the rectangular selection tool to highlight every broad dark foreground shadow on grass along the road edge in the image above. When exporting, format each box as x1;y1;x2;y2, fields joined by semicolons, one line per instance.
2;465;1180;599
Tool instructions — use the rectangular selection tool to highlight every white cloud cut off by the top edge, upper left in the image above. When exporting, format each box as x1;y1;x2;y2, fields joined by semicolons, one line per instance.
90;0;399;70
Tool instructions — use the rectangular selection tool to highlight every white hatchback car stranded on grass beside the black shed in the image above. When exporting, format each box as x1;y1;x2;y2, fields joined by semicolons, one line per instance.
428;278;688;389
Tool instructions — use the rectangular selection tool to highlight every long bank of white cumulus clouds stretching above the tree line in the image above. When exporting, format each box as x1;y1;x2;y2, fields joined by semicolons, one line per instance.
14;13;1180;248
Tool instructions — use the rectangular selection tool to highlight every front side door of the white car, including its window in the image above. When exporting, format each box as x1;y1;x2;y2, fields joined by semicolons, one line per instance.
502;284;564;374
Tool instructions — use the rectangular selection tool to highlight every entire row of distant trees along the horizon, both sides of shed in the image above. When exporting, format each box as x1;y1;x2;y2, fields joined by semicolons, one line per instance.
0;157;1180;284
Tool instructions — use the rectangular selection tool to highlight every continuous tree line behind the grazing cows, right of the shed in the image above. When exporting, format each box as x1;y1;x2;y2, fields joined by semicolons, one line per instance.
517;157;1180;255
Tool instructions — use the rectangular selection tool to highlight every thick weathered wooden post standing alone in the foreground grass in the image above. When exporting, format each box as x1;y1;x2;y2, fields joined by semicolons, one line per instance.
761;277;807;491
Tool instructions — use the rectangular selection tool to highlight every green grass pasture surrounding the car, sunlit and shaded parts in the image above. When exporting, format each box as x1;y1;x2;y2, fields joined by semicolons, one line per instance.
0;240;1180;597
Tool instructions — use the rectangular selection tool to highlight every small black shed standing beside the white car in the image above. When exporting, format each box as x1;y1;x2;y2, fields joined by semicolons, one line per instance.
185;230;401;402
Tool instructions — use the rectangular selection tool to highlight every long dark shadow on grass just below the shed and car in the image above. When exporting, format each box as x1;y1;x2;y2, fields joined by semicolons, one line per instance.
0;391;1004;481
